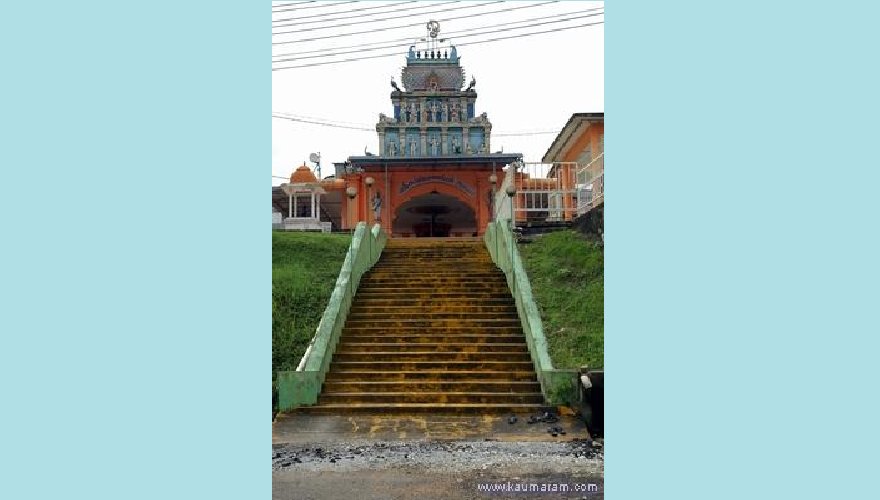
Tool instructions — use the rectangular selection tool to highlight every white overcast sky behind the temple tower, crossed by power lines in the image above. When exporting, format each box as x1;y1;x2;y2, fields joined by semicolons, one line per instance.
272;0;605;185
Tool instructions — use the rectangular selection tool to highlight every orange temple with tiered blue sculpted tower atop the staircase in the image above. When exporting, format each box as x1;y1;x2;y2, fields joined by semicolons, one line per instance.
273;23;522;237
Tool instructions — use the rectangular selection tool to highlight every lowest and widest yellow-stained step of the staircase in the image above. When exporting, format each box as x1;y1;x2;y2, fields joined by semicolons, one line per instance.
297;403;544;415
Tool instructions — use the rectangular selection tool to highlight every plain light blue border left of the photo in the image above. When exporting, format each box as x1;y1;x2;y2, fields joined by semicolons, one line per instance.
0;1;271;500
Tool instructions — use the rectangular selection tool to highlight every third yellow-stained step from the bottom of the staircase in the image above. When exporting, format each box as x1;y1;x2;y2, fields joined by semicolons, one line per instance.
323;378;541;393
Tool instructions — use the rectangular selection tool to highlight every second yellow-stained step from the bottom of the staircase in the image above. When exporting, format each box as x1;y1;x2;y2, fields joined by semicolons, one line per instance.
318;392;544;405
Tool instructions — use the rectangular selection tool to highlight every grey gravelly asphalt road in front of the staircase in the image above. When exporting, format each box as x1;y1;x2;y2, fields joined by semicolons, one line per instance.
272;440;604;500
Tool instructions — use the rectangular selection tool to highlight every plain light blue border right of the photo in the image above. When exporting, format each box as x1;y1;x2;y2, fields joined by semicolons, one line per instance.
605;1;880;500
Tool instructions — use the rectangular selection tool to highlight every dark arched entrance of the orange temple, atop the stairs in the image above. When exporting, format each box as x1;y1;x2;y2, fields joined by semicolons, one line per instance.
392;191;477;238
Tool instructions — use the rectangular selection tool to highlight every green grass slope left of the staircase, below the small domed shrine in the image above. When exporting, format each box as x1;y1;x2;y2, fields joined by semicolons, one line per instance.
272;231;351;380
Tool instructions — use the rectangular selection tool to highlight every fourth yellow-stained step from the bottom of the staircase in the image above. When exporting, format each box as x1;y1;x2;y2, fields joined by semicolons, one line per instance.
324;367;538;384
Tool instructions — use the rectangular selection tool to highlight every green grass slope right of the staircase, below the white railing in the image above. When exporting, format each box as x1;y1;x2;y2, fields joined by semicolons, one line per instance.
518;231;605;368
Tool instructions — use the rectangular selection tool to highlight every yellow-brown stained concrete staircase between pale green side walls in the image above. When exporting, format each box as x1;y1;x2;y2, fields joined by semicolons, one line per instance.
306;238;544;413
